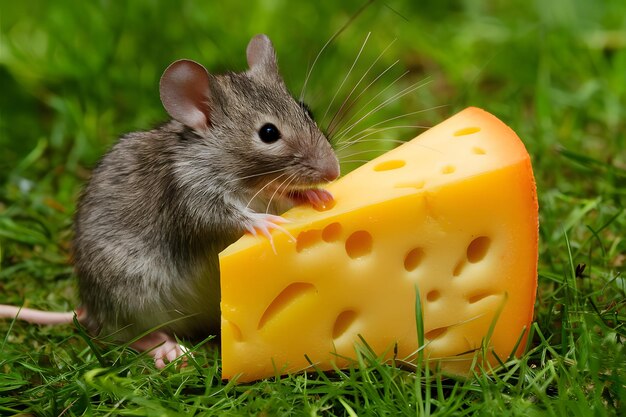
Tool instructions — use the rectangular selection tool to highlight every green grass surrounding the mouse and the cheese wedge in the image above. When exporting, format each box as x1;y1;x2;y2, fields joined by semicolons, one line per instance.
0;0;626;416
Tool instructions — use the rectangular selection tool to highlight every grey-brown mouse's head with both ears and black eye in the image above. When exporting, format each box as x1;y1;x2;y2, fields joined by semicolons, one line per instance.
160;35;339;192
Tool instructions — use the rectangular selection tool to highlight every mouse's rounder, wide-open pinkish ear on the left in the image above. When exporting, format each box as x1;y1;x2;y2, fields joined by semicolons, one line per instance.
159;59;210;131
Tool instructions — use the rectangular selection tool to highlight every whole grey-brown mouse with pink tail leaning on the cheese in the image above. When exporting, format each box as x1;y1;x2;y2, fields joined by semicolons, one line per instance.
0;34;340;368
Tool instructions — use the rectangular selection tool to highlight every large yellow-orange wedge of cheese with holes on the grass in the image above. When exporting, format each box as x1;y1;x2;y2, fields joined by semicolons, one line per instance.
220;108;538;382
